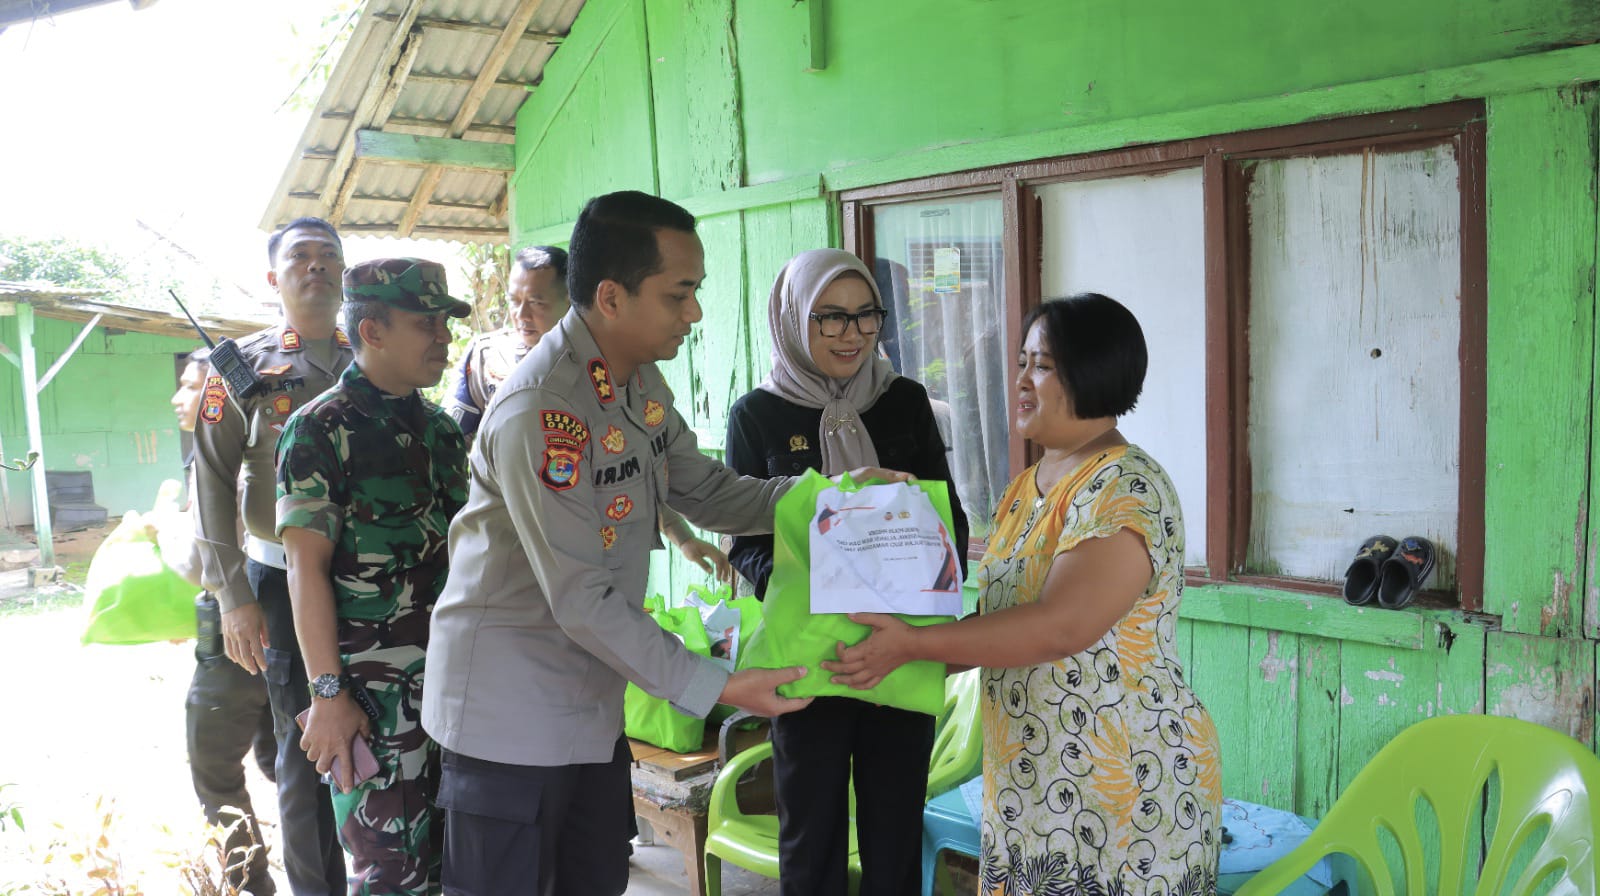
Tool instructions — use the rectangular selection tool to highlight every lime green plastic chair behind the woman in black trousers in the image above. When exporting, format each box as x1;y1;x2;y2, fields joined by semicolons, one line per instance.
706;669;982;896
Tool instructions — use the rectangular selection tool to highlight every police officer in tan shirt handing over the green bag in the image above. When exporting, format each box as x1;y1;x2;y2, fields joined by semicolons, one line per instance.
422;192;906;896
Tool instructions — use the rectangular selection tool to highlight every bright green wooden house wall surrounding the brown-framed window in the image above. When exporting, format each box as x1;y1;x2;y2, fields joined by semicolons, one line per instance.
510;0;1600;816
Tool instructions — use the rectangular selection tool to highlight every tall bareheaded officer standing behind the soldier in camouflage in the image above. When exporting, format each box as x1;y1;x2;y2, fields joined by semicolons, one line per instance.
195;218;354;896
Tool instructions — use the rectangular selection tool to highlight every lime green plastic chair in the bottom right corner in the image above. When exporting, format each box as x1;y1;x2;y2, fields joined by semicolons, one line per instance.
1237;715;1600;896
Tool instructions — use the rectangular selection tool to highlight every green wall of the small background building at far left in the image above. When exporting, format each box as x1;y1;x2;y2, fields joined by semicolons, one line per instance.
0;317;197;526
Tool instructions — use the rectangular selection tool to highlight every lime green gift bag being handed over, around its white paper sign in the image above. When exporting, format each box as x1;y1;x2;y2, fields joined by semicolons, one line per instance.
739;470;954;715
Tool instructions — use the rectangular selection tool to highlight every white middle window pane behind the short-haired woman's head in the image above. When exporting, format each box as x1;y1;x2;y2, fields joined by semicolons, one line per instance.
1037;168;1206;566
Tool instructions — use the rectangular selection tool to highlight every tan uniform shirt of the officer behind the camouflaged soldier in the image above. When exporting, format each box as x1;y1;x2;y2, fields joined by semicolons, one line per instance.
195;325;355;613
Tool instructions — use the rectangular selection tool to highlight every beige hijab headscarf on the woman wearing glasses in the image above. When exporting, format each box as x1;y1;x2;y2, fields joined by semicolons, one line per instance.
760;250;899;475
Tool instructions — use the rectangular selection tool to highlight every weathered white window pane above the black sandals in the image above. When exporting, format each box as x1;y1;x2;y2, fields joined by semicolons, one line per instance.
1246;144;1461;589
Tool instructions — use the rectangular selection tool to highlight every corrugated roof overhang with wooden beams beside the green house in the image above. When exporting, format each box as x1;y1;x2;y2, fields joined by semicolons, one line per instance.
261;0;584;242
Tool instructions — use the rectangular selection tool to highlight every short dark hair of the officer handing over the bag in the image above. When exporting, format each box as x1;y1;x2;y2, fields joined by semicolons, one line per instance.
566;190;694;310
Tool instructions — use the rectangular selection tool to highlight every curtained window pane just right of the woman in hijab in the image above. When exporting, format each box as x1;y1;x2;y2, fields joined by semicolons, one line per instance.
872;195;1011;539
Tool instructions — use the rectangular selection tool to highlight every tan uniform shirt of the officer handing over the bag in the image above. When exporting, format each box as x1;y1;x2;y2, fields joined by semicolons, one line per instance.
422;309;792;766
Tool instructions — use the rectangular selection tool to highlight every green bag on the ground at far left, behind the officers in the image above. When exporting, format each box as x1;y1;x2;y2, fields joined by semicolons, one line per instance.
82;510;197;645
